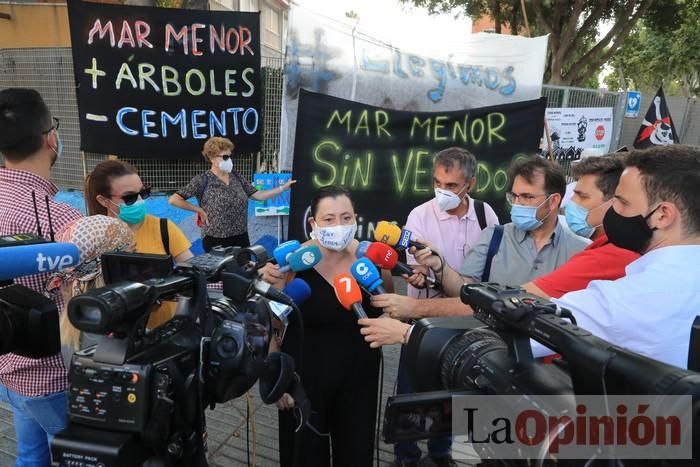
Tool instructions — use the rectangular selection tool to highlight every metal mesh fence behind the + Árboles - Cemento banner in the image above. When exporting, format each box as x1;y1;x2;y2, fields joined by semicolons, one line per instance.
0;48;284;191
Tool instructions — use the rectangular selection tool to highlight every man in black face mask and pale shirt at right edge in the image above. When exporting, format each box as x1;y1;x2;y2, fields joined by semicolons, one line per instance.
533;145;700;368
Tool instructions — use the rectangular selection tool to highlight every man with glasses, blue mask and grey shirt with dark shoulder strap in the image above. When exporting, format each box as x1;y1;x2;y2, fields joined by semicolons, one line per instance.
370;157;588;322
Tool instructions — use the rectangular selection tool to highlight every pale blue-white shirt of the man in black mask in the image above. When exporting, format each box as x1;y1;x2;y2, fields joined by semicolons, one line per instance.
532;245;700;368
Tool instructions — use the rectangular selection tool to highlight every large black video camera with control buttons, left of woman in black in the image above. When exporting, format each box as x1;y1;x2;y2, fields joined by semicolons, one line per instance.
52;246;295;467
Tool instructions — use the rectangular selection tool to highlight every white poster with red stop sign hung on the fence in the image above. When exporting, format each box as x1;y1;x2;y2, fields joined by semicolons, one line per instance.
542;107;613;160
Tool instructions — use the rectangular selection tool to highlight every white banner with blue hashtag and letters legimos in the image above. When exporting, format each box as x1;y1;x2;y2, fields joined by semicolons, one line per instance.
280;5;547;170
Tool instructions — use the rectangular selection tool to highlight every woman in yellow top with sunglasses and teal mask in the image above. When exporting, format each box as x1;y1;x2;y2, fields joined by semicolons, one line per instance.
85;160;192;327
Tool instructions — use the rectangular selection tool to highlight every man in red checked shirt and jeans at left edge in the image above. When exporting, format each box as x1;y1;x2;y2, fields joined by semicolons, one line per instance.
0;88;81;466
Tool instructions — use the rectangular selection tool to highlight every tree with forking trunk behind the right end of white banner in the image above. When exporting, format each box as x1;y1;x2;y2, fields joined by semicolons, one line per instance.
400;0;679;86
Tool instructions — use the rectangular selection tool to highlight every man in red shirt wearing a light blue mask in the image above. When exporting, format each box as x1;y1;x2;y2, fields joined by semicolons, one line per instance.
523;155;639;299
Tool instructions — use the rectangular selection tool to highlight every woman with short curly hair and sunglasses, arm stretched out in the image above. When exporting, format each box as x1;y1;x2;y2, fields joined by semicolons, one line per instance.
168;137;295;251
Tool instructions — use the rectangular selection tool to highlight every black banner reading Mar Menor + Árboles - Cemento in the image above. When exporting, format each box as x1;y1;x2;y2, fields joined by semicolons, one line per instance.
68;1;262;159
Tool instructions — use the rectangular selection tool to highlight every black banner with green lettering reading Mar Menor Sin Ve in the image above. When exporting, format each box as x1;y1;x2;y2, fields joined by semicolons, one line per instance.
289;90;545;240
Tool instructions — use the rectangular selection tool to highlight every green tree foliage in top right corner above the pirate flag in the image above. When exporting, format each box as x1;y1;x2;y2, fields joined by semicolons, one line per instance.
605;0;700;97
